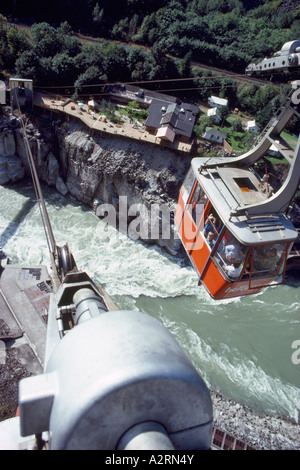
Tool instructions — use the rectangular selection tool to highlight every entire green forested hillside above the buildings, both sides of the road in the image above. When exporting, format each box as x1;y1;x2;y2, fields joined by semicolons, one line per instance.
0;0;300;134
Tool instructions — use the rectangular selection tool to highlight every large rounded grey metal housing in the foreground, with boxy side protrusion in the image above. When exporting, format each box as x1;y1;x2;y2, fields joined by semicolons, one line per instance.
19;310;213;450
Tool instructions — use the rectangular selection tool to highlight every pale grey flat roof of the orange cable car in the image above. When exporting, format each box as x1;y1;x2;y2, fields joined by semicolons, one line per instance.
192;157;296;245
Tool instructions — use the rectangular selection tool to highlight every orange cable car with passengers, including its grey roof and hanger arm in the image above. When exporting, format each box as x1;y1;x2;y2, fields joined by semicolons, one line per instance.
175;81;300;300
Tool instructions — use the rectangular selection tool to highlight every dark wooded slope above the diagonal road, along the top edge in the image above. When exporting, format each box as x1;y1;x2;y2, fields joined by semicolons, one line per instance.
0;0;300;71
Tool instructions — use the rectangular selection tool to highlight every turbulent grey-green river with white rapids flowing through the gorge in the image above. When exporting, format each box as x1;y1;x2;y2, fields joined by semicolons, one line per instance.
0;182;300;419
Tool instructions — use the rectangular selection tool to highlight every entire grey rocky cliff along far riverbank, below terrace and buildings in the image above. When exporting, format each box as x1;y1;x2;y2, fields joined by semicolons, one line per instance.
0;115;190;253
